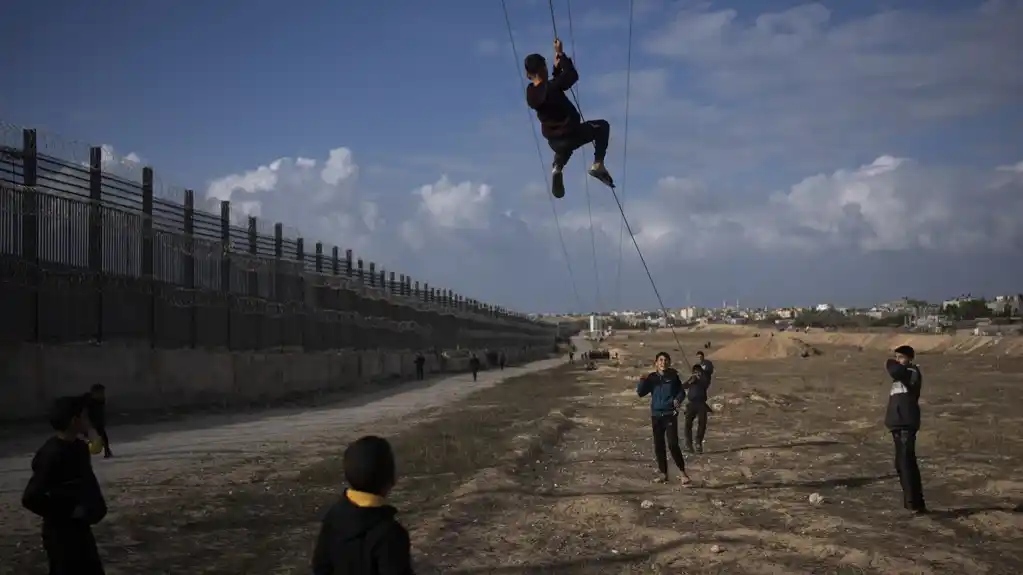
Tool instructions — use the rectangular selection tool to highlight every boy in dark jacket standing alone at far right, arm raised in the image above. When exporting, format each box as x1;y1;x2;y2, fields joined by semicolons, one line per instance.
885;346;927;515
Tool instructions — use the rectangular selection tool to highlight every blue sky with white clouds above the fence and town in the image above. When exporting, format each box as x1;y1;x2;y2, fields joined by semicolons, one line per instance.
0;0;1023;312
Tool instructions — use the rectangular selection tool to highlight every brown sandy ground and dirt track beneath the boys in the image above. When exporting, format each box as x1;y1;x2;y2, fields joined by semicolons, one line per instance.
0;330;1023;575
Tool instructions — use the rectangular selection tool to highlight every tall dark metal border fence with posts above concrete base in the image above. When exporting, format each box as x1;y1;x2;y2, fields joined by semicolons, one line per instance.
0;124;555;351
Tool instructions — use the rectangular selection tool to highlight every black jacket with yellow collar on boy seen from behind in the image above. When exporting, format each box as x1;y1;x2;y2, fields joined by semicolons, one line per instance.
312;496;413;575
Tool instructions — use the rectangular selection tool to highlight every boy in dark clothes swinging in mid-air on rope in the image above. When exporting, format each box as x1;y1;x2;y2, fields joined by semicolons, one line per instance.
525;39;615;197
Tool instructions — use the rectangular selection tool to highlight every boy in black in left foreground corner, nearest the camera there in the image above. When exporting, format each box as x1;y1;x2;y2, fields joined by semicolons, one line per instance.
21;395;106;575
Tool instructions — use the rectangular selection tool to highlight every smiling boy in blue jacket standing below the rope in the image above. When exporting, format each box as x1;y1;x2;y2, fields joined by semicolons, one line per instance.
636;352;692;485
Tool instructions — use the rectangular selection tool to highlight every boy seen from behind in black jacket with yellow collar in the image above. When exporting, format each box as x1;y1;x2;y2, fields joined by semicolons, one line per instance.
312;436;413;575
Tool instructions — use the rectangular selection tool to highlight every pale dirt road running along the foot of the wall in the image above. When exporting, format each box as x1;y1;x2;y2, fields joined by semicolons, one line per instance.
0;341;586;575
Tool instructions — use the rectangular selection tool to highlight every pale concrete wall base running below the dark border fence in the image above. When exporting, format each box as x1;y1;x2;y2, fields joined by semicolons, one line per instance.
0;344;550;422
